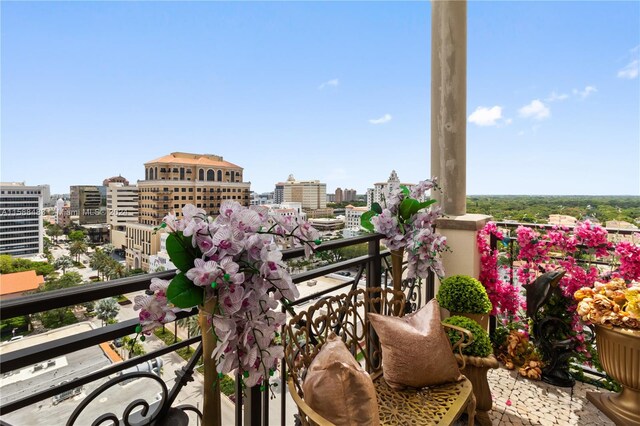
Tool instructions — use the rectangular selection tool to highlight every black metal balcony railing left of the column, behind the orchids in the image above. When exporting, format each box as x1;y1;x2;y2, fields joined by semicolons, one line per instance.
0;234;433;425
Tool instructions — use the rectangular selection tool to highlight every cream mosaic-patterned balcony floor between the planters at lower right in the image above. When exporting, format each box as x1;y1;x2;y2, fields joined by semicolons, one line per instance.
455;368;614;426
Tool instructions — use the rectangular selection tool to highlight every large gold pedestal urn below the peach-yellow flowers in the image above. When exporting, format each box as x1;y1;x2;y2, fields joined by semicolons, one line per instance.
587;325;640;426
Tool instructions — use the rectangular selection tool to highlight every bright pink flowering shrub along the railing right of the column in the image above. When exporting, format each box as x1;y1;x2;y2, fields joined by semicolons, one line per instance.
477;221;640;380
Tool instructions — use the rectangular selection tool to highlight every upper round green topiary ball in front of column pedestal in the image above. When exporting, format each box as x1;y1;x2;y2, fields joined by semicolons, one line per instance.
436;275;492;314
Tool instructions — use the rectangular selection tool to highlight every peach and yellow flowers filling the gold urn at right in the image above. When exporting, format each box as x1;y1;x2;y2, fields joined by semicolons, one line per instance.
574;278;640;329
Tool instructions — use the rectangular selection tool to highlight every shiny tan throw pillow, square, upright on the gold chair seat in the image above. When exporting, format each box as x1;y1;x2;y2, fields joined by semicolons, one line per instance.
369;299;462;389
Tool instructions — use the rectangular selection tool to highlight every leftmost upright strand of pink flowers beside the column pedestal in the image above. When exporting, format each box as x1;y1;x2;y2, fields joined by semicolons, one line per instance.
476;222;522;315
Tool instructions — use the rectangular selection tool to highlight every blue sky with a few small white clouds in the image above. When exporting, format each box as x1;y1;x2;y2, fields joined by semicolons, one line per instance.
0;2;640;195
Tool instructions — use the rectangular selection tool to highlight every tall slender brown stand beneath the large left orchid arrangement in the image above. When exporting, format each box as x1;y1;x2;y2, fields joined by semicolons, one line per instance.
199;297;222;426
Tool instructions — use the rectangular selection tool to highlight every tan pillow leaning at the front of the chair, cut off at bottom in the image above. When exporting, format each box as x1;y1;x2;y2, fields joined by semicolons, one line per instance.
302;333;380;426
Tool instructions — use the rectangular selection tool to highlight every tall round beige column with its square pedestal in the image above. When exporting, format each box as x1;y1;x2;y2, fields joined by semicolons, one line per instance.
431;0;490;286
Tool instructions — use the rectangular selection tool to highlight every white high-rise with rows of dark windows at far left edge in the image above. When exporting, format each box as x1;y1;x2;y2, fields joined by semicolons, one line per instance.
0;182;44;257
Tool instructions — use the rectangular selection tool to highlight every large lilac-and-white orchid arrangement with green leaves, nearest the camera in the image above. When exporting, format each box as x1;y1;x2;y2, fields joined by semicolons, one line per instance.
134;201;320;386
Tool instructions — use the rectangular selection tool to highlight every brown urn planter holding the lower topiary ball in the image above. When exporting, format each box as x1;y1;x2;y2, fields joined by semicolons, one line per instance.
456;354;500;426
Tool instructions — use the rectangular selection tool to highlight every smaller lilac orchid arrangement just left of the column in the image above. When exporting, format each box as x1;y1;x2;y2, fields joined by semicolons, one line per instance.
360;178;447;278
